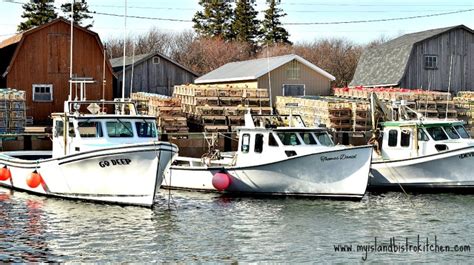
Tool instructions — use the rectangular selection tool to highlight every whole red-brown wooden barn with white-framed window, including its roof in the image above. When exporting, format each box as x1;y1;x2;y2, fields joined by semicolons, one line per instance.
0;18;113;124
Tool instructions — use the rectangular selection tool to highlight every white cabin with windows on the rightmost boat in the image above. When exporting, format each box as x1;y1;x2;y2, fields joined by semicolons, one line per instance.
376;120;474;160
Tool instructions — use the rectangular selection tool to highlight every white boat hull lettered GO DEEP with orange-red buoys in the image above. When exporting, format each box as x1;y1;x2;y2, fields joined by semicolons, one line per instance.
0;142;178;207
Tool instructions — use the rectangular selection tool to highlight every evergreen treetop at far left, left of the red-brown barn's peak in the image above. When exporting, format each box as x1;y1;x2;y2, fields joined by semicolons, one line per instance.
17;0;58;32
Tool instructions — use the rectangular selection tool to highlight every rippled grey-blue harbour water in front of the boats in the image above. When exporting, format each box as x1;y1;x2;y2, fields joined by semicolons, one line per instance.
0;188;474;263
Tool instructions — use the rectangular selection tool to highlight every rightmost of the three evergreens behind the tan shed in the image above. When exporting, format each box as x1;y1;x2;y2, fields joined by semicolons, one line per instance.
262;0;292;44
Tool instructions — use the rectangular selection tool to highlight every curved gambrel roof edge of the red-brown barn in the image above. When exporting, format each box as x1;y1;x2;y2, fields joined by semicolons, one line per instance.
0;17;114;78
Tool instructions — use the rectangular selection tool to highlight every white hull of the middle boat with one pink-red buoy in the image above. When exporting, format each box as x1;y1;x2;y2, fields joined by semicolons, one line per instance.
163;146;372;198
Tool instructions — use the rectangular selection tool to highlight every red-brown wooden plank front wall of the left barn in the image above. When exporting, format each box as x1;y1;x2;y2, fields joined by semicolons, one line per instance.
7;20;113;124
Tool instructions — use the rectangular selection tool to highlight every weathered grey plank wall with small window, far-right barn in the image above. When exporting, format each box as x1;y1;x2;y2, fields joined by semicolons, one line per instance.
400;29;474;92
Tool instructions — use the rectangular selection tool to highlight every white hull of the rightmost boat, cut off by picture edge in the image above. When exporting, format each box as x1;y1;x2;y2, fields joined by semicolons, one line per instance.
369;146;474;192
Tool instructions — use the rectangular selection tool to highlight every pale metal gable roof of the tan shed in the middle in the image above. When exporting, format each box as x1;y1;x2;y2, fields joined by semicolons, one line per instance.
194;54;336;84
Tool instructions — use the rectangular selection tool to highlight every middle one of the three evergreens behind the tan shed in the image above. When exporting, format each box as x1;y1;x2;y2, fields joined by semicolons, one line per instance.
232;0;260;46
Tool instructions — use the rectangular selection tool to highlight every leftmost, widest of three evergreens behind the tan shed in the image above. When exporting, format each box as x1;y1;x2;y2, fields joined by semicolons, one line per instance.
193;0;233;40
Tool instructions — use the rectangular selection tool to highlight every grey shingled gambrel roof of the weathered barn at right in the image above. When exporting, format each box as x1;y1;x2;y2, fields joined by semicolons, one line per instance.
349;25;472;86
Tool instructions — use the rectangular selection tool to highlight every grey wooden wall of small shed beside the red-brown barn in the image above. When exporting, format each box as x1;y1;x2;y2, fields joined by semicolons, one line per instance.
115;55;196;97
